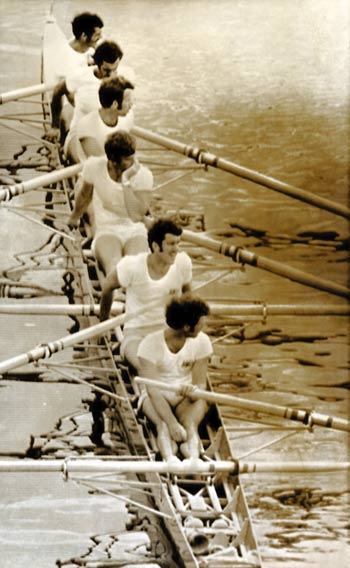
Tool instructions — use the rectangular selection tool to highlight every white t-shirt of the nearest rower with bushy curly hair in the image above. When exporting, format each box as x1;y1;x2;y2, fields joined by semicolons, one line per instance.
137;330;213;386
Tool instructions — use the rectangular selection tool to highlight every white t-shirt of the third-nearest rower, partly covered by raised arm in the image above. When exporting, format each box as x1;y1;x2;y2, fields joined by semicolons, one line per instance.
82;156;153;230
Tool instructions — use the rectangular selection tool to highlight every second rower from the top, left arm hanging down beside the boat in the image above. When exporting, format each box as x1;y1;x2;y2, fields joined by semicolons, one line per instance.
46;41;134;153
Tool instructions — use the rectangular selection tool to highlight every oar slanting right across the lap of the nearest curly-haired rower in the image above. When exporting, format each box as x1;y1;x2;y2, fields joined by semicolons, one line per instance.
135;377;350;432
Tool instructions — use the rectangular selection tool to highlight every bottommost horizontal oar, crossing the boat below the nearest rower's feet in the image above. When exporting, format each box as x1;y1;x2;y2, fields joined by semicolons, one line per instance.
0;458;350;478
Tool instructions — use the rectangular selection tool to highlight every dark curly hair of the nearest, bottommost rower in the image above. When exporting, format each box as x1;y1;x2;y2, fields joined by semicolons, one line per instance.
165;296;209;330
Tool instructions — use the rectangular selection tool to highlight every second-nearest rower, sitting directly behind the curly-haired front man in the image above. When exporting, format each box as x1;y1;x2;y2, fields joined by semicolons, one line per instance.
100;219;192;370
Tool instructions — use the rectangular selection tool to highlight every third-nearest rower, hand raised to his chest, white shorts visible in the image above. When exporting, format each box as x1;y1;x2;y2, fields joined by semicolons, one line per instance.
68;131;153;274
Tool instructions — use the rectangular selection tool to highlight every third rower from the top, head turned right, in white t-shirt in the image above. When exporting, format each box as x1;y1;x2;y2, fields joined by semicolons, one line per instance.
76;77;134;162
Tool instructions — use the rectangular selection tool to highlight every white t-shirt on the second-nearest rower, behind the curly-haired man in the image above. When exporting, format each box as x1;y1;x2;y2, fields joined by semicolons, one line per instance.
116;252;192;330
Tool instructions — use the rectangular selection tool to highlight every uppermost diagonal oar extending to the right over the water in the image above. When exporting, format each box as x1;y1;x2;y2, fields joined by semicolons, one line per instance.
132;126;350;219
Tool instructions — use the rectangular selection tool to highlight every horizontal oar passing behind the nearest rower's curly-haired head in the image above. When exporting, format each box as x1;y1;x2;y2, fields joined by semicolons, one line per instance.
0;300;350;319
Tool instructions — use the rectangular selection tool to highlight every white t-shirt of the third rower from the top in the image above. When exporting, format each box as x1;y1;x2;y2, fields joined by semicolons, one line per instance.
77;109;134;161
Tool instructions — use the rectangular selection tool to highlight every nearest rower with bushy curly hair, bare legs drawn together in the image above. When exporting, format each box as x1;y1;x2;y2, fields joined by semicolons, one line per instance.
137;296;213;460
